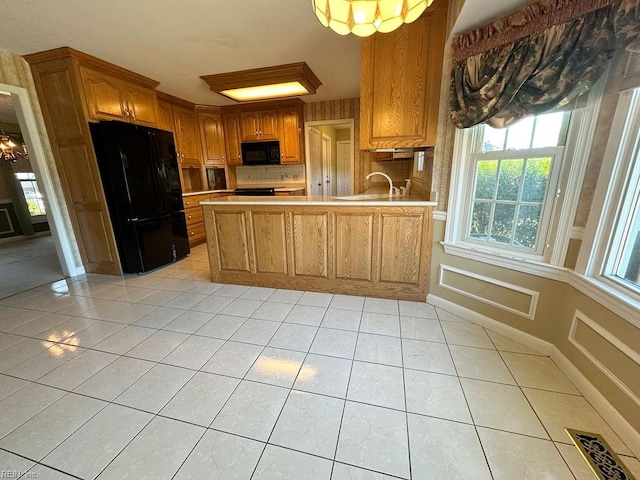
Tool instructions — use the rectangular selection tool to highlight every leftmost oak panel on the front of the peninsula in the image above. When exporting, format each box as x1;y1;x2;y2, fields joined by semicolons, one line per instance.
214;212;250;272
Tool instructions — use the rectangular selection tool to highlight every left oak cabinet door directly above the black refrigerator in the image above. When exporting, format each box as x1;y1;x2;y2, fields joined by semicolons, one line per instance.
80;67;128;120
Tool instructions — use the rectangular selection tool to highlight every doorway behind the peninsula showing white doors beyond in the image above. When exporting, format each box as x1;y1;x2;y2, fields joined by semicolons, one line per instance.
305;118;355;196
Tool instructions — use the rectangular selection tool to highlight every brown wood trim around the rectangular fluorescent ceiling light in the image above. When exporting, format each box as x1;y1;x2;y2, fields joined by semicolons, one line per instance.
200;62;322;94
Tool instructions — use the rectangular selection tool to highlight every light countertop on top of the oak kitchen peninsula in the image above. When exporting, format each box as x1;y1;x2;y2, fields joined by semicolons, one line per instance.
200;194;438;207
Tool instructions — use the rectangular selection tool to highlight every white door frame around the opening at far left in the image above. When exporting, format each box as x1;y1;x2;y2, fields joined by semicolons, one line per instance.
0;83;86;277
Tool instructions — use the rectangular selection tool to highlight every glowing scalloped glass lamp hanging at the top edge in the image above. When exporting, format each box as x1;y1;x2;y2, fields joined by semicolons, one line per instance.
311;0;433;37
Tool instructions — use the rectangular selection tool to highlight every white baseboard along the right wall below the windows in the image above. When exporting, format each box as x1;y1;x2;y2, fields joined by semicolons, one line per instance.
427;294;640;458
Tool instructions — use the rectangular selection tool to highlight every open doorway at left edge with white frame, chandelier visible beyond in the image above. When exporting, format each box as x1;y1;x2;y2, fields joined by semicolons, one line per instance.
0;84;84;298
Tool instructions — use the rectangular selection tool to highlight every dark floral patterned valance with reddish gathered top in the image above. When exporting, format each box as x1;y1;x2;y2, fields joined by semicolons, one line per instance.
451;0;640;128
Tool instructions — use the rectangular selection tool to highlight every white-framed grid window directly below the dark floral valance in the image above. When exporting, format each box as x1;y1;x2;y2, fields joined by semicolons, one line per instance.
462;112;571;256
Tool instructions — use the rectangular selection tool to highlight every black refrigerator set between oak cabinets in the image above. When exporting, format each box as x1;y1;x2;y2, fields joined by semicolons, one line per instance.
90;121;189;273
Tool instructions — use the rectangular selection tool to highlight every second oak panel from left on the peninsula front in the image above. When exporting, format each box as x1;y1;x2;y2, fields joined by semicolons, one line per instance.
251;212;288;275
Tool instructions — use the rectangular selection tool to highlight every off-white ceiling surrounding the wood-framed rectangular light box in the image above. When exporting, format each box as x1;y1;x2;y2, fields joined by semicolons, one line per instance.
0;0;527;105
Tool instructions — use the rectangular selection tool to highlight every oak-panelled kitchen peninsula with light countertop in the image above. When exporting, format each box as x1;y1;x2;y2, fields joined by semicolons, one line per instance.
200;195;436;301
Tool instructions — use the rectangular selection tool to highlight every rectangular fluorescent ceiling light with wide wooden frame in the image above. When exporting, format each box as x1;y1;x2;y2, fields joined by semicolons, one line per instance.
200;62;322;102
